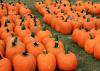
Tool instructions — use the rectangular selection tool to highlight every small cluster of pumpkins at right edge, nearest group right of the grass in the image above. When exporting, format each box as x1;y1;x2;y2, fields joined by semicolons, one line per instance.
72;27;100;60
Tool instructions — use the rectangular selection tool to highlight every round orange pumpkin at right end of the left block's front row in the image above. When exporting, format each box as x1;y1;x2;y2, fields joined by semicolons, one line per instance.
57;52;78;71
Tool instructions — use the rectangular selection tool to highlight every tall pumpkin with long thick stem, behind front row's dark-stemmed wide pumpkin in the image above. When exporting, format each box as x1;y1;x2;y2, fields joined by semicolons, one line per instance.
6;36;25;61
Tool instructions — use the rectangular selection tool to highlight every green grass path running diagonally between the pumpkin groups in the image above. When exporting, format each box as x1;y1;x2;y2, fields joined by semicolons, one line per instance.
8;0;100;71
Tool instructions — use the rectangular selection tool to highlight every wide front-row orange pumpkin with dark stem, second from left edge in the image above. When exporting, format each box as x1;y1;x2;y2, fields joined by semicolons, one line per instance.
13;52;36;71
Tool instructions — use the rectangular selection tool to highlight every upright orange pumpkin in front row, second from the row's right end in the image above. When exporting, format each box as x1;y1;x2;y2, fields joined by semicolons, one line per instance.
37;51;56;71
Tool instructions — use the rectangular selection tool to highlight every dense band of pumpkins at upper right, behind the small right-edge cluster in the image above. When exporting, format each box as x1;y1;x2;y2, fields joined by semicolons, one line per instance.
35;0;100;34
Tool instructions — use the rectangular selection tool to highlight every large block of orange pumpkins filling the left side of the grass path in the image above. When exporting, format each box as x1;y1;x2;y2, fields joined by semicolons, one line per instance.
0;2;78;71
